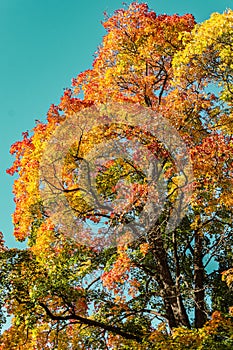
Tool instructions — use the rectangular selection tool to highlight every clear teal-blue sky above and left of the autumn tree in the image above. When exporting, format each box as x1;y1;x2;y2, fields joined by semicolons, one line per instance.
0;0;233;246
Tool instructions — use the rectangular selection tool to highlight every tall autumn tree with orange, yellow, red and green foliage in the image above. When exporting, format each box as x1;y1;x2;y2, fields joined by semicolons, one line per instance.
1;3;233;349
